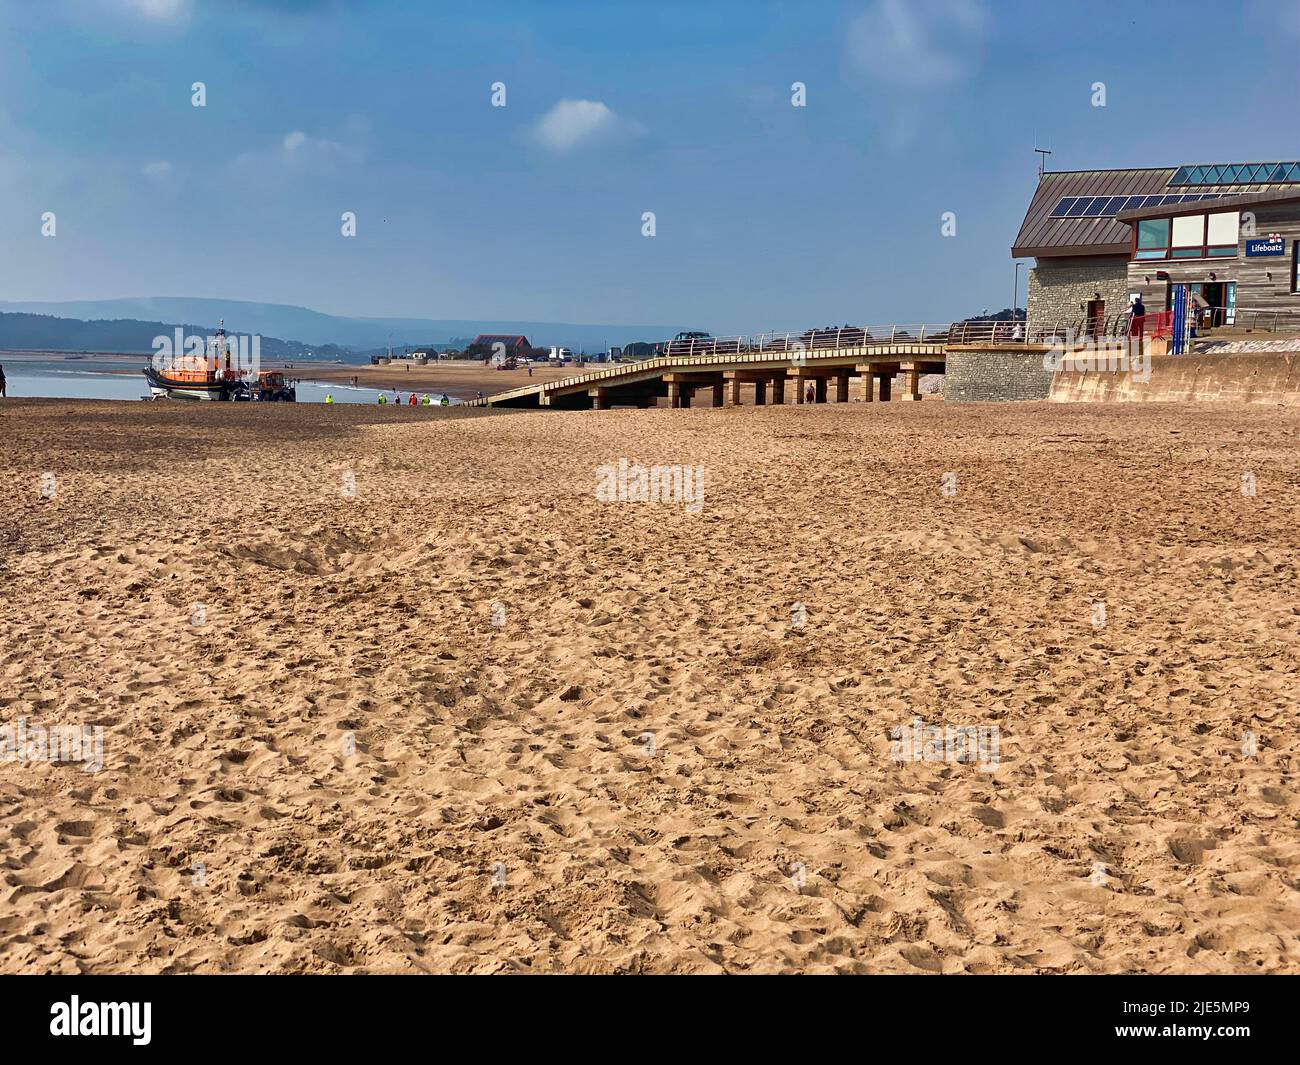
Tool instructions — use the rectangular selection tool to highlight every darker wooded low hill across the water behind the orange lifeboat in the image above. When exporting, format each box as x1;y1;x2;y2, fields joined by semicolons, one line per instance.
0;313;351;359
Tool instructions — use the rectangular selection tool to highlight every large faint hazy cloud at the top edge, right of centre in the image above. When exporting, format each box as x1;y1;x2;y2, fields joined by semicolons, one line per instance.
845;0;992;88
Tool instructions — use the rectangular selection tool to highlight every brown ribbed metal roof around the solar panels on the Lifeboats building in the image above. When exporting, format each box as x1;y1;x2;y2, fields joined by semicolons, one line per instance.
1011;164;1300;259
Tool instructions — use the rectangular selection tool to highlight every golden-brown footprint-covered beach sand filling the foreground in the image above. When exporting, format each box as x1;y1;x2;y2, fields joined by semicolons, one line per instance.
0;397;1300;973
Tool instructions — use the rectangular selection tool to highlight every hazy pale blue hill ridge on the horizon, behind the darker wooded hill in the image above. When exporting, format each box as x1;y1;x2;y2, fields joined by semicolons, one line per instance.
0;296;686;352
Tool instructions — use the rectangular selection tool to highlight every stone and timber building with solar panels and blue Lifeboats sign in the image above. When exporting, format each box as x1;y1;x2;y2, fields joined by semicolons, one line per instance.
1011;163;1300;335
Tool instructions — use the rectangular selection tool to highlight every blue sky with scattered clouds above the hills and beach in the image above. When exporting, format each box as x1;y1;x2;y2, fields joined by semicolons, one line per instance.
0;0;1300;333
